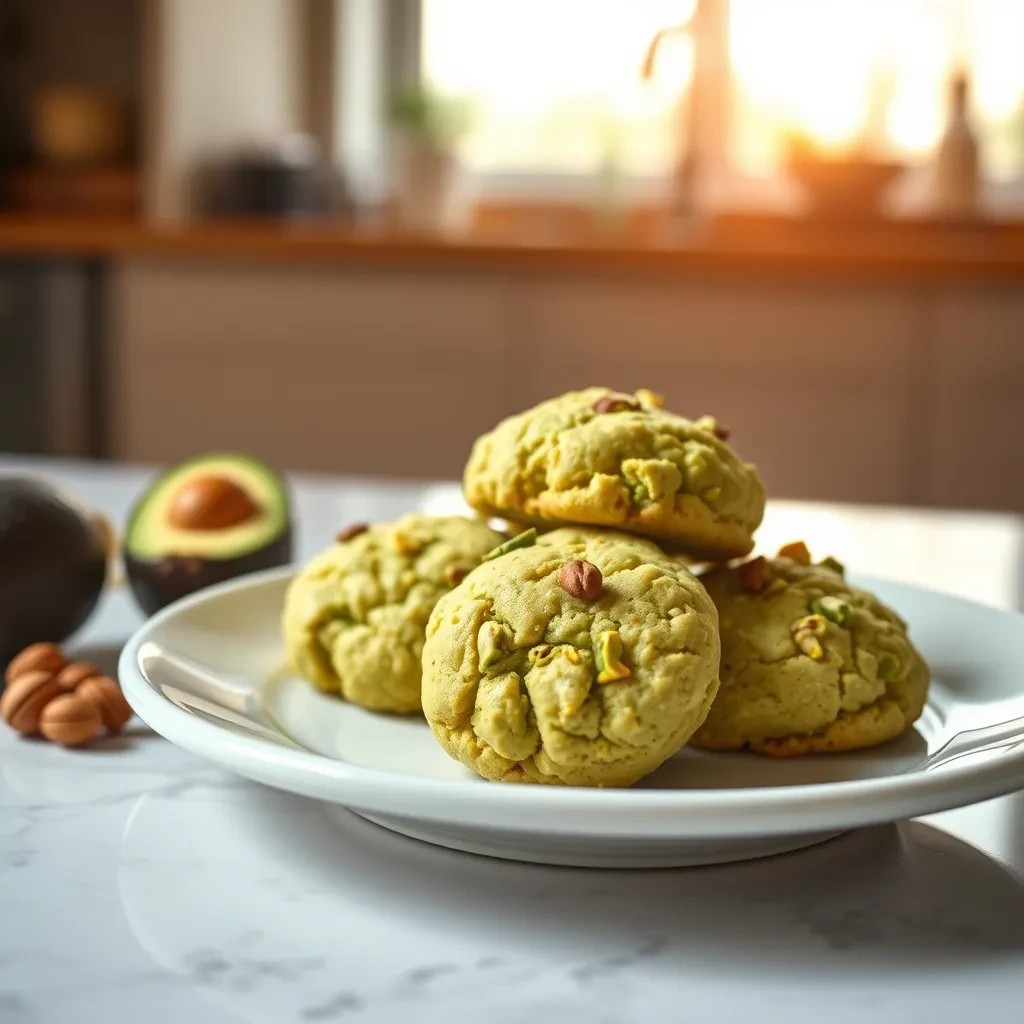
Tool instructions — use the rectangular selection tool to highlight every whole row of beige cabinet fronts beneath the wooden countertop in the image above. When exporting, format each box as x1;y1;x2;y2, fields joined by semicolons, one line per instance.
110;257;1024;509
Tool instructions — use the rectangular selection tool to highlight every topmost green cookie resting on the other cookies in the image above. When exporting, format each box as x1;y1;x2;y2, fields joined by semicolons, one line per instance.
463;387;765;561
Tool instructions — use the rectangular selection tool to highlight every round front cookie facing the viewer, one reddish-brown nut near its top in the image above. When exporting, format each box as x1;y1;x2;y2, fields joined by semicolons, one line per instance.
423;529;719;786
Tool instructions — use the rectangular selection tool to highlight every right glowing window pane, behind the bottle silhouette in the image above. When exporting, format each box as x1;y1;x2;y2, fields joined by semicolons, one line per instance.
730;0;1024;163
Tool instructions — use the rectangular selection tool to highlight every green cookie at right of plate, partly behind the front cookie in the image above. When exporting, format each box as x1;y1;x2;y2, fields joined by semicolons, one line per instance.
692;544;929;757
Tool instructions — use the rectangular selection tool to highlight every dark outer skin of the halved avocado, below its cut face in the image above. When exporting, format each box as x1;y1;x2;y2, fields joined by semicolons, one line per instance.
125;525;292;615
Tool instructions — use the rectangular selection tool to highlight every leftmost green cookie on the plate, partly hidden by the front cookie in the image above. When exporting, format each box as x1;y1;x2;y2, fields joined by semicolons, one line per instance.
284;515;505;713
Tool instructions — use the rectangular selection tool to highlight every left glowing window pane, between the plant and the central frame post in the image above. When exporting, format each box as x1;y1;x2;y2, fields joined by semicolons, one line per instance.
423;0;692;174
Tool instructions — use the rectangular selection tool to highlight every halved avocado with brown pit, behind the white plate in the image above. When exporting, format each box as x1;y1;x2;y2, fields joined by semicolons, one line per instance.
124;452;292;615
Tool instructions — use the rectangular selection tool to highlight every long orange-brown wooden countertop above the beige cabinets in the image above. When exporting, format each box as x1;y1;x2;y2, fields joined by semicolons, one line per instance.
0;215;1024;280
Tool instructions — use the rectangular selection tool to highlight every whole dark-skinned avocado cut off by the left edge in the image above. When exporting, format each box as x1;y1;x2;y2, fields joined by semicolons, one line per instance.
0;476;109;671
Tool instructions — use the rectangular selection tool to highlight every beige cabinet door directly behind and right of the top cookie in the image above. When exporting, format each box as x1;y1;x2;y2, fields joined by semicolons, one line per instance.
517;280;927;503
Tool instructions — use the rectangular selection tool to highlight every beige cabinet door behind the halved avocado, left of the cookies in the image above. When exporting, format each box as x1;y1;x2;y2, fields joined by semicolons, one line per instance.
112;261;518;477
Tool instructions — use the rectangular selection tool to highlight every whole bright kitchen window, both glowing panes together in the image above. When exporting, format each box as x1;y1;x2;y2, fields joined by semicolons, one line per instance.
419;0;1024;198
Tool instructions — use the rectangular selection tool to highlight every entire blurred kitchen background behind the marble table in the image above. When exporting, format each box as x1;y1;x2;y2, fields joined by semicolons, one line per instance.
0;0;1024;510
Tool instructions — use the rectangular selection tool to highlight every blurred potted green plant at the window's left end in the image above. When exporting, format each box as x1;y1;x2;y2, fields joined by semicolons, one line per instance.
388;87;470;233
